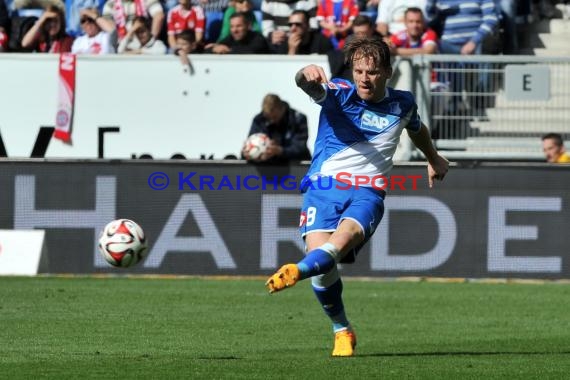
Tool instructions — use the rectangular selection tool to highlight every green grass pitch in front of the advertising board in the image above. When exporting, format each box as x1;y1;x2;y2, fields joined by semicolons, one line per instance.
0;277;570;380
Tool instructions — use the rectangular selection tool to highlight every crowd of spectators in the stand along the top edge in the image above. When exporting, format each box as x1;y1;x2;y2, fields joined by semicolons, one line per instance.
0;0;555;56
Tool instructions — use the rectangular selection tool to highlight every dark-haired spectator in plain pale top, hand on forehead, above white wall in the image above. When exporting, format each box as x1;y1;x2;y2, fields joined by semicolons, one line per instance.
117;17;168;55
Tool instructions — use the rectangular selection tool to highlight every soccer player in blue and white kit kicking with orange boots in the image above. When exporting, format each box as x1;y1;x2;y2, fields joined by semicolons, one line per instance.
266;38;449;356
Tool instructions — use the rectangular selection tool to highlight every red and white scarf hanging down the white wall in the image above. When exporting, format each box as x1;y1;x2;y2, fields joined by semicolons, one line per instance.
54;53;77;143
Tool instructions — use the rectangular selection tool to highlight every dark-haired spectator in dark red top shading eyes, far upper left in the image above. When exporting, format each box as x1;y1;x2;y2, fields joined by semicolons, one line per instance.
22;5;73;53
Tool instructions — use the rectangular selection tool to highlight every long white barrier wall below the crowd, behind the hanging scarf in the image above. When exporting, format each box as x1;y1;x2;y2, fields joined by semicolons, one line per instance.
0;54;407;159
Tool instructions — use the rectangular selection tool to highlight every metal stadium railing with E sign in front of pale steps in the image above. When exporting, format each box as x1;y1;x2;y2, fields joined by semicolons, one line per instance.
395;55;570;161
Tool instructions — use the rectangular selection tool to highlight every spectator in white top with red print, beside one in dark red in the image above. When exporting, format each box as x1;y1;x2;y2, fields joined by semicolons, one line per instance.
71;8;117;54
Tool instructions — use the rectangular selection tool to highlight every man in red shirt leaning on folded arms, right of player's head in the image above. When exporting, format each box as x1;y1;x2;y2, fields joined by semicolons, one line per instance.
388;7;437;57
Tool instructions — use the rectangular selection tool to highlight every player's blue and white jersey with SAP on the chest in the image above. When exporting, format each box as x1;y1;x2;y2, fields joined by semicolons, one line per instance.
307;78;421;186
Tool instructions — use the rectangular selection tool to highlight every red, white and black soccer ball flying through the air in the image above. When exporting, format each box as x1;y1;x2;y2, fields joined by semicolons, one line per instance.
99;219;147;268
